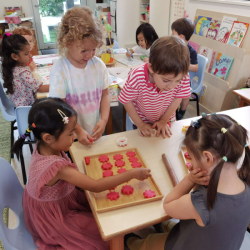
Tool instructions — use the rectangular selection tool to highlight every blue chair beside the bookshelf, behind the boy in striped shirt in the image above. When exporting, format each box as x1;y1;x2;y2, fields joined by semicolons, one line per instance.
189;54;208;116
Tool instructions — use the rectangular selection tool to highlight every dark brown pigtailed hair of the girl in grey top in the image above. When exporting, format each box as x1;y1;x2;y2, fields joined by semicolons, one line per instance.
184;115;250;210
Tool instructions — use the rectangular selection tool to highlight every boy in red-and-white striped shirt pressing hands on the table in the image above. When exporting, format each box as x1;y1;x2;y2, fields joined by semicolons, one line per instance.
119;36;190;138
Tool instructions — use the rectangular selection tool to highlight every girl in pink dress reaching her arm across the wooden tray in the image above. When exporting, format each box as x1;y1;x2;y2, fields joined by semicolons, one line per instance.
13;98;150;250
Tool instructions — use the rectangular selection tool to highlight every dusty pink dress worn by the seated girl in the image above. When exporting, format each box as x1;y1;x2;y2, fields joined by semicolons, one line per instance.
23;148;109;250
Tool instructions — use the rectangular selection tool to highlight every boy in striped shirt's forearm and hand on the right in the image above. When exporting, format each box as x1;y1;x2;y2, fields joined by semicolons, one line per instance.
152;98;182;138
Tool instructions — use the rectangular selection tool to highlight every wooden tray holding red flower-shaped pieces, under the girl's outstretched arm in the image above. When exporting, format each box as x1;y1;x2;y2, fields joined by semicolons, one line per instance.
83;148;163;213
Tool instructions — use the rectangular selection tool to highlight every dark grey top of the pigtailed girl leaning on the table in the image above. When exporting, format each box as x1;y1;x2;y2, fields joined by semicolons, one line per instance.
164;184;250;250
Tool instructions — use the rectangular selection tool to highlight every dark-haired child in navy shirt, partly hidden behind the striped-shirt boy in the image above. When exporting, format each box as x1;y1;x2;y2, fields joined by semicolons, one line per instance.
171;18;198;120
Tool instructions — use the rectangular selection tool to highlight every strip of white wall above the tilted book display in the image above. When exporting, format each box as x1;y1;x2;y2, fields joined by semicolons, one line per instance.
186;0;250;20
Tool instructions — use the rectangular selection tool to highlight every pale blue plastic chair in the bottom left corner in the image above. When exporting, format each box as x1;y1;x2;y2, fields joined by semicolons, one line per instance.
0;158;37;250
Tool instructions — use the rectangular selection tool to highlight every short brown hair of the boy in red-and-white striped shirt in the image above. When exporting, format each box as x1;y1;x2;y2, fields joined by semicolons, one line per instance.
149;36;190;76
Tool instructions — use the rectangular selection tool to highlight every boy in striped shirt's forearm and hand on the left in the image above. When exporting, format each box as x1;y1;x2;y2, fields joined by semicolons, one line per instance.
123;102;154;137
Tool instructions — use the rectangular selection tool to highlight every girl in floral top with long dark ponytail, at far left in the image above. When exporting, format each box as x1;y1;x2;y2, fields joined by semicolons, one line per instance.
1;33;49;107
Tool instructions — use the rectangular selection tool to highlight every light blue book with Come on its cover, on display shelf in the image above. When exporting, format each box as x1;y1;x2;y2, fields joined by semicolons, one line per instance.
211;52;234;80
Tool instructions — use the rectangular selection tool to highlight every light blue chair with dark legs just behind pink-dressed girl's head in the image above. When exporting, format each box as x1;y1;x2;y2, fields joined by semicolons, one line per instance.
16;106;36;185
